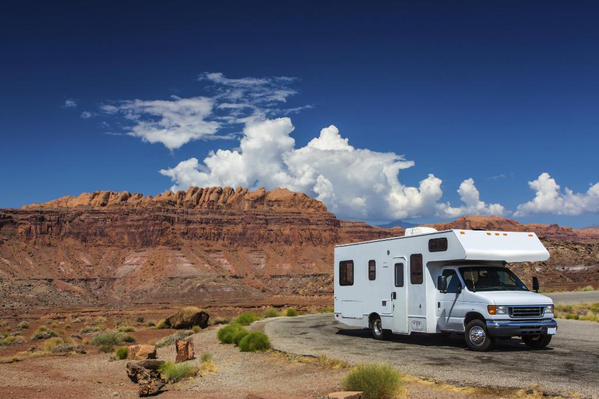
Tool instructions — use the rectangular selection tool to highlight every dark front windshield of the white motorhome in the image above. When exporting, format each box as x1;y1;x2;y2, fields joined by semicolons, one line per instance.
460;266;528;291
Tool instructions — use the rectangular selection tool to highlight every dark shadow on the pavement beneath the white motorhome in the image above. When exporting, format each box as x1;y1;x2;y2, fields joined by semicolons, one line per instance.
337;328;552;352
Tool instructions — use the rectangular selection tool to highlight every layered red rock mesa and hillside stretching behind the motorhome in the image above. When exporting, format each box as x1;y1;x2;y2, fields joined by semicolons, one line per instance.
0;187;599;310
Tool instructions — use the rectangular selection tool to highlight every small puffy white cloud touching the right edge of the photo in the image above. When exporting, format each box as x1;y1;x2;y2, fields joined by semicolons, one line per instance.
514;172;599;216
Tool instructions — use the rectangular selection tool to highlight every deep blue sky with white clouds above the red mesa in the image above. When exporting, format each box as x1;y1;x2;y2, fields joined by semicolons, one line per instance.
0;1;599;226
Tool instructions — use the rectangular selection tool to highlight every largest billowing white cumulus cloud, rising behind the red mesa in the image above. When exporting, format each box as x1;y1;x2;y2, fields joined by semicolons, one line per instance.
160;117;504;220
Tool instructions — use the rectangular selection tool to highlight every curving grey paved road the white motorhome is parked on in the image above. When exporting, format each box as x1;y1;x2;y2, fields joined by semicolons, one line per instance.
264;314;599;398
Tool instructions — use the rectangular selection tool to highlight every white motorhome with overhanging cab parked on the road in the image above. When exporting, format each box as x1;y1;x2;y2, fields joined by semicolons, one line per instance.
335;227;557;351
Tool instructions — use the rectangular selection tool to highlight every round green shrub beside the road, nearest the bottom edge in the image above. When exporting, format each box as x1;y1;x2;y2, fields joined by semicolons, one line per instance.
342;364;403;399
